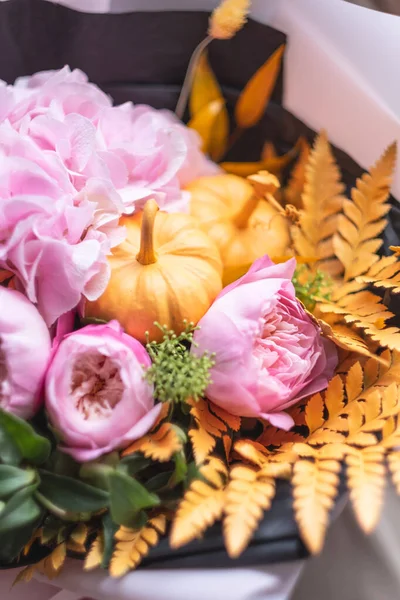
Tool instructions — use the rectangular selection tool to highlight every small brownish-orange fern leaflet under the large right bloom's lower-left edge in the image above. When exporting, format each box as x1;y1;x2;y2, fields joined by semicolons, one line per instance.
189;398;228;464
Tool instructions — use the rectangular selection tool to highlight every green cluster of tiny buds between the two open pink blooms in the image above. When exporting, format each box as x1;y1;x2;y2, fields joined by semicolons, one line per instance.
146;323;215;403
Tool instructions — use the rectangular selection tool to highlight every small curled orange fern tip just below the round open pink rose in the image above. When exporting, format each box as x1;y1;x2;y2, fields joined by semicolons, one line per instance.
122;423;182;462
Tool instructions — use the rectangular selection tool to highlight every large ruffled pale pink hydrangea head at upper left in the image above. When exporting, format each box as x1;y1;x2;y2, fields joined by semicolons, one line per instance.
0;67;216;325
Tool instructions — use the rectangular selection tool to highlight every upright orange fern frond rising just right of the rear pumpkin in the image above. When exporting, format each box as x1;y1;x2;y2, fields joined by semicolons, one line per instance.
292;132;345;275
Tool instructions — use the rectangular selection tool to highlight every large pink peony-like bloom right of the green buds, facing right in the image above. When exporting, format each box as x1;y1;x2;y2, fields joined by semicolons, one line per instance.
192;256;338;429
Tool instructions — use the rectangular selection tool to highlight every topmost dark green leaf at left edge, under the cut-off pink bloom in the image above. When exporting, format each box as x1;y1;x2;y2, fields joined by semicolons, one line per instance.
0;409;51;465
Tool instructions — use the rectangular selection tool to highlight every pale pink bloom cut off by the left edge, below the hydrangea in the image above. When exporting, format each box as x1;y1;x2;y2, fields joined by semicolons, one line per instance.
0;287;51;419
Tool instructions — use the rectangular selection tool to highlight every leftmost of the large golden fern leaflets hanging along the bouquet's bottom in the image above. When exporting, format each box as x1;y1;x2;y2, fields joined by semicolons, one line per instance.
170;457;228;548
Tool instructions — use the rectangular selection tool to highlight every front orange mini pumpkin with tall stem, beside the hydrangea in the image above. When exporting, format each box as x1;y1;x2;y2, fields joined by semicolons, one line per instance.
85;200;222;342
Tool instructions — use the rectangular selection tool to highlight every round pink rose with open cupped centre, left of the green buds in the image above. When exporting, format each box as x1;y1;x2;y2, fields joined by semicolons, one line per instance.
45;321;161;462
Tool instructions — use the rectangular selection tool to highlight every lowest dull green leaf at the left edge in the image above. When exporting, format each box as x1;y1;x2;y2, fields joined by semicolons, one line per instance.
0;485;42;540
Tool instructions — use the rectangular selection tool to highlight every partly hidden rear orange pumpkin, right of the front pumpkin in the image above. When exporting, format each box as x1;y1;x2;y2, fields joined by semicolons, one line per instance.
187;174;290;284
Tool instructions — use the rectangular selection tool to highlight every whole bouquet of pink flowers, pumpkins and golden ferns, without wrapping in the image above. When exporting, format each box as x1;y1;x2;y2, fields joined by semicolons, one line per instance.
0;0;400;580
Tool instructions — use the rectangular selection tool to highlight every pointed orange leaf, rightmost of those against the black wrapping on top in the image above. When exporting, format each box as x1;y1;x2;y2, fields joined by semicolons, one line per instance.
235;44;285;129
